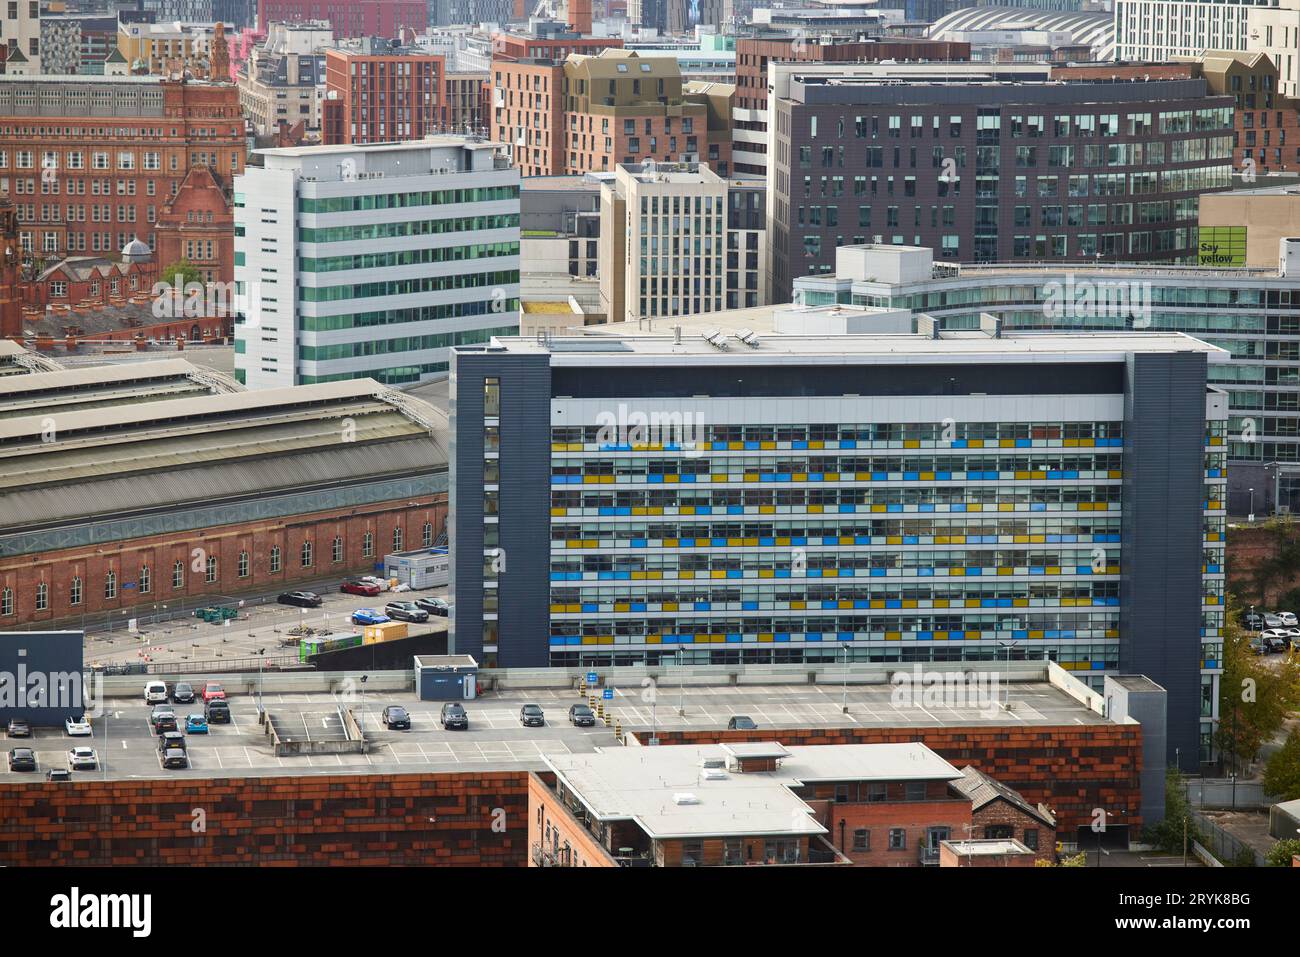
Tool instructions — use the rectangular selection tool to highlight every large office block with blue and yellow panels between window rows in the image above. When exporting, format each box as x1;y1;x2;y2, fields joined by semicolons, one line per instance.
450;319;1227;761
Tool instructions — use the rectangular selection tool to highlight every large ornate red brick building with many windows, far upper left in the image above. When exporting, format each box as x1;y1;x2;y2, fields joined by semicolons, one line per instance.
0;77;246;277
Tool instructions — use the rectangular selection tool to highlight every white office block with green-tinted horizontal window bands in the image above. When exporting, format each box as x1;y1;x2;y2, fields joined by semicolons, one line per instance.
235;137;520;389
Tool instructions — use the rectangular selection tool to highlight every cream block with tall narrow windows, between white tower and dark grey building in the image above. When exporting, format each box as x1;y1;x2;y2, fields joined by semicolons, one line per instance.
598;163;766;322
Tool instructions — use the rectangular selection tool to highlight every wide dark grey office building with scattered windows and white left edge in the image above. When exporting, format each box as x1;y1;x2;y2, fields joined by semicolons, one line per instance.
768;64;1232;291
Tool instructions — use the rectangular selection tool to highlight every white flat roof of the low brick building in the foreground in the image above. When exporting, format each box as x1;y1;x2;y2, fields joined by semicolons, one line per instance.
543;742;961;840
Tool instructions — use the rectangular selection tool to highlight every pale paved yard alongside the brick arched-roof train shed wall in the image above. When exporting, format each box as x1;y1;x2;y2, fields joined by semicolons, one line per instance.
85;579;447;670
